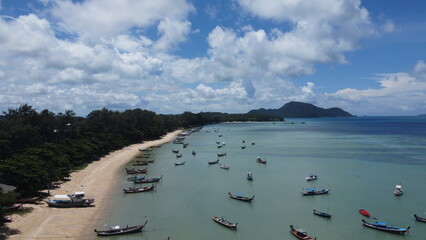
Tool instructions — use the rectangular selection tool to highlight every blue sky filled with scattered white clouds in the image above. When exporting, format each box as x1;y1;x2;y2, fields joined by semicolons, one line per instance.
0;0;426;116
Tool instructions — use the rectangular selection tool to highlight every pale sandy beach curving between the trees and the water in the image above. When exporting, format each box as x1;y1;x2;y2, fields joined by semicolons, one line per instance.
7;130;181;239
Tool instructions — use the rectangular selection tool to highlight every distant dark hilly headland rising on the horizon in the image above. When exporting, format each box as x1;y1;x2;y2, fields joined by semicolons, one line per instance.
248;102;354;118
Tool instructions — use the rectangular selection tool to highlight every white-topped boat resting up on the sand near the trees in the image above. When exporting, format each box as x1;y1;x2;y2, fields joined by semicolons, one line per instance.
45;192;95;208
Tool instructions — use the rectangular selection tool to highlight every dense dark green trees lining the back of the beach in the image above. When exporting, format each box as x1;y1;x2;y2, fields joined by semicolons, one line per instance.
0;104;280;202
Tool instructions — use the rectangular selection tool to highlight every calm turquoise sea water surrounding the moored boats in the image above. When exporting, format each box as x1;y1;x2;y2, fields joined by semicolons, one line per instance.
95;117;426;240
